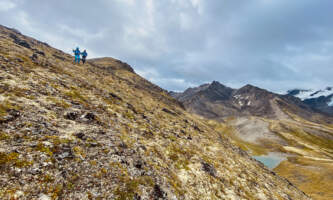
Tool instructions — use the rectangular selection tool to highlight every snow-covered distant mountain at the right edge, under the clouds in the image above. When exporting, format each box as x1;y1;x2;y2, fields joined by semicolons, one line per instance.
287;87;333;116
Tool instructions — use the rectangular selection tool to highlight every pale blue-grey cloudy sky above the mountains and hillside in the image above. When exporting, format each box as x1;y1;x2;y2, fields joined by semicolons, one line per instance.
0;0;333;92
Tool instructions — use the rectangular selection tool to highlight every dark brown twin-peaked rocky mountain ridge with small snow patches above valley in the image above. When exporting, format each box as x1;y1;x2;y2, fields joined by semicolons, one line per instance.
170;81;331;123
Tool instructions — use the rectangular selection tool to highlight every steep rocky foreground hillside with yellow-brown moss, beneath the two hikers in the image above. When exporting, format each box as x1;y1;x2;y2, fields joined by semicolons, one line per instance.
0;26;310;200
